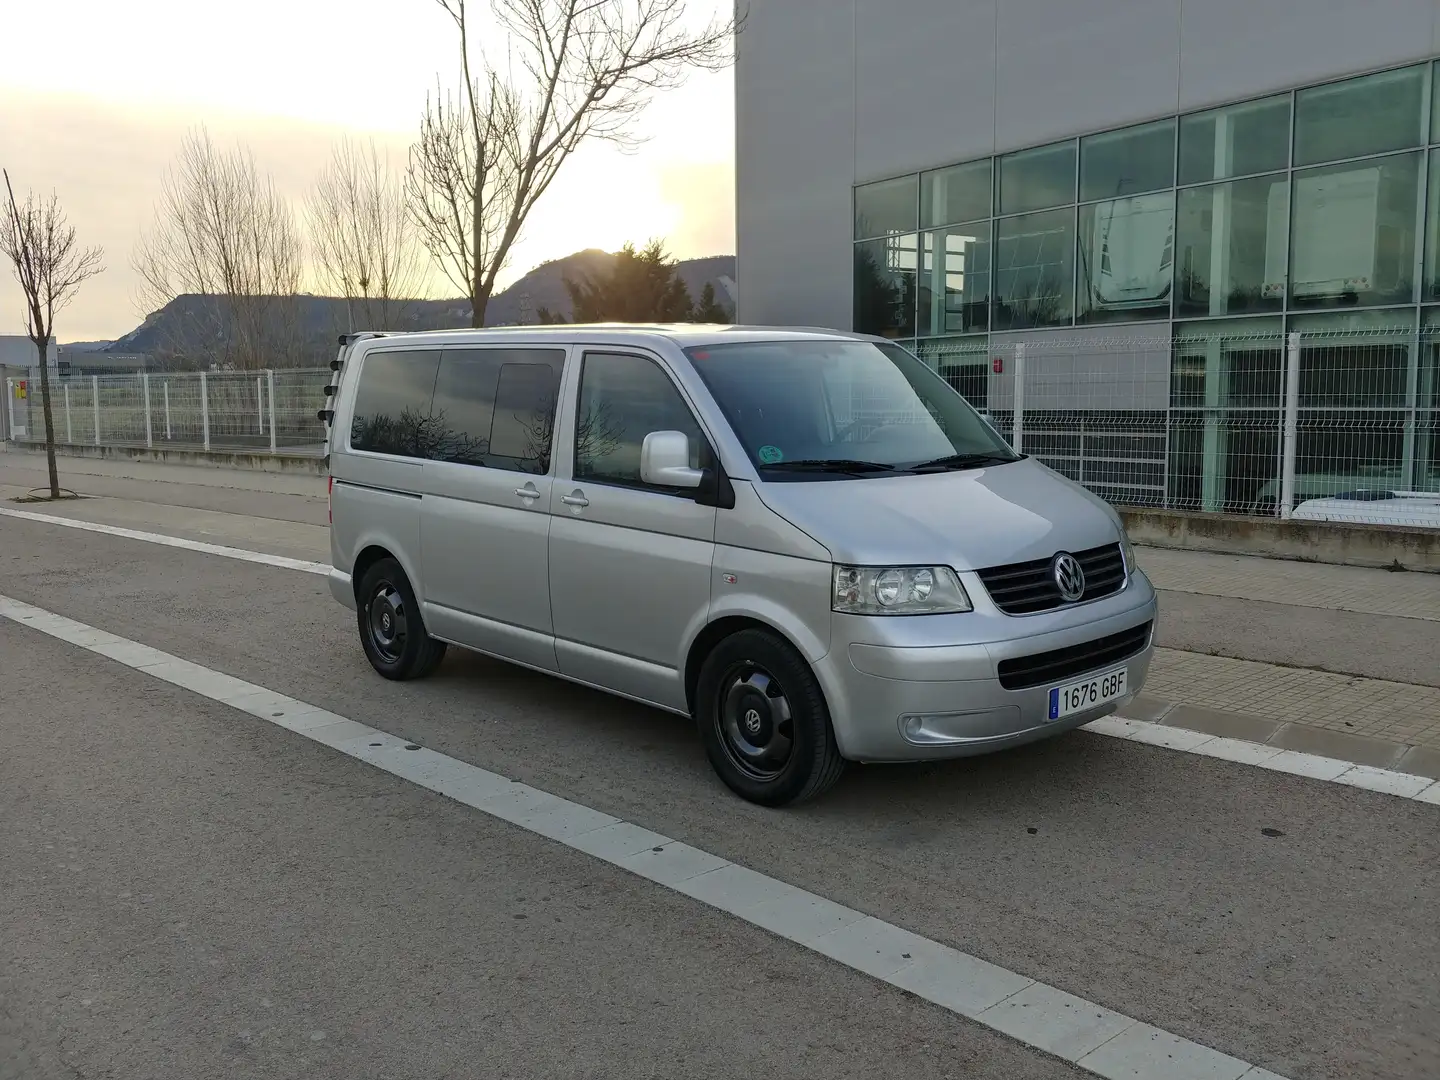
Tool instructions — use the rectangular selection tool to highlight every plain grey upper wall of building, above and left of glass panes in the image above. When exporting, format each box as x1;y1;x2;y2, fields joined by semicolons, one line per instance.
736;0;1440;328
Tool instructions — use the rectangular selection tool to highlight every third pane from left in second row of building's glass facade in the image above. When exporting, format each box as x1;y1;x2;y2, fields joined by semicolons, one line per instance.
991;209;1076;330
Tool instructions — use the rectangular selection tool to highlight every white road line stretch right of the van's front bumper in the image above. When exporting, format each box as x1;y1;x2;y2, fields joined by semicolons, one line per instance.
1081;716;1440;806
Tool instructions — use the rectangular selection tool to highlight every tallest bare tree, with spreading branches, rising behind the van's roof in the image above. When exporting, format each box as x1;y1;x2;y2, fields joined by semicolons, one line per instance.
408;0;737;327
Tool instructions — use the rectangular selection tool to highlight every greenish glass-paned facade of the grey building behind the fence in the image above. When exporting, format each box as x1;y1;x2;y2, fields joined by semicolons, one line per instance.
852;62;1440;511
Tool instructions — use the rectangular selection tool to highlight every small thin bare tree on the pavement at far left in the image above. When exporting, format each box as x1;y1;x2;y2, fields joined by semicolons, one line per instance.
0;173;105;498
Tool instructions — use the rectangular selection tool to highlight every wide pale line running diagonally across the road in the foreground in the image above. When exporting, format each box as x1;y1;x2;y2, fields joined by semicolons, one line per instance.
0;595;1283;1080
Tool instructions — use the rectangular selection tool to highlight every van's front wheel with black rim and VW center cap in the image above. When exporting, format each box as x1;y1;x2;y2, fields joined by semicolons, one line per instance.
694;629;845;806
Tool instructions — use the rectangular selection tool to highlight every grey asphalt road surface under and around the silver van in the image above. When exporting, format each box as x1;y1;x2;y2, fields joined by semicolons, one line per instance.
0;504;1440;1080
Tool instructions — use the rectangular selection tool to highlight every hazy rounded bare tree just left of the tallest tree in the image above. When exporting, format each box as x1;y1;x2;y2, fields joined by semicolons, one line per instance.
305;138;426;330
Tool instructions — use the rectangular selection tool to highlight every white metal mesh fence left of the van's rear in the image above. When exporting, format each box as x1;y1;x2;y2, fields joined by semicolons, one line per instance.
6;369;331;454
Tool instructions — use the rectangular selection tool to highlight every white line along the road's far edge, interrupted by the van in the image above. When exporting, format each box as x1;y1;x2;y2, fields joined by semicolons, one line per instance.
0;507;1440;806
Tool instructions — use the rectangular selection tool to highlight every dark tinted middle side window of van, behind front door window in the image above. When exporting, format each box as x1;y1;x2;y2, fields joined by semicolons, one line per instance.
428;348;564;474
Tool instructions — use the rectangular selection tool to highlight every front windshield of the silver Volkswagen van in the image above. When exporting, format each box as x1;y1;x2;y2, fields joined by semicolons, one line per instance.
685;341;1021;481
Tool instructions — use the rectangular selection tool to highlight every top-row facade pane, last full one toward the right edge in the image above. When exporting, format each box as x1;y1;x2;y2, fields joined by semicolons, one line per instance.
1295;66;1426;166
